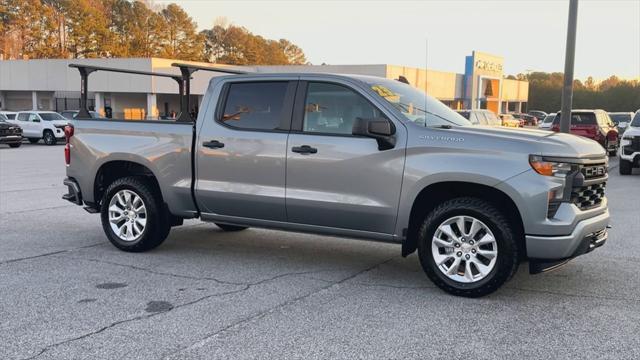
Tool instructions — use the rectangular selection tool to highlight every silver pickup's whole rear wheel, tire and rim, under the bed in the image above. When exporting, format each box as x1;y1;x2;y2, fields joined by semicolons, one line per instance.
101;176;171;252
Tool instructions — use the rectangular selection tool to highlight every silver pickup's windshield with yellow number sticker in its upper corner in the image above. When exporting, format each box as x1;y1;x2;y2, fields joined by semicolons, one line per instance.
365;79;471;126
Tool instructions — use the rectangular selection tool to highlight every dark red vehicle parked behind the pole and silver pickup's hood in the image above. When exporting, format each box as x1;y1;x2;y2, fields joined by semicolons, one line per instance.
551;109;620;156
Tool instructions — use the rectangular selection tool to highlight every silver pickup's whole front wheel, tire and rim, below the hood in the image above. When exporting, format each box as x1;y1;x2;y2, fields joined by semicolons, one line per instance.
418;197;519;297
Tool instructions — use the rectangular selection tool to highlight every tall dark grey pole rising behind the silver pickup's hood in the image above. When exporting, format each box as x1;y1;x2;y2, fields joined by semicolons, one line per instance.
560;0;578;133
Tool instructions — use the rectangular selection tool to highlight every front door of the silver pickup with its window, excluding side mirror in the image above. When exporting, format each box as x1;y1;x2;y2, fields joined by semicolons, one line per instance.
287;81;404;234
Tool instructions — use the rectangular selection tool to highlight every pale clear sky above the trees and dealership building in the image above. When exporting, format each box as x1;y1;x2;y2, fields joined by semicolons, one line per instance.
153;0;640;80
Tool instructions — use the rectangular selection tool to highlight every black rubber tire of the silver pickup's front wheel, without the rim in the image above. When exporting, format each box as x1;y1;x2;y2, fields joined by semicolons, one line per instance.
418;197;520;298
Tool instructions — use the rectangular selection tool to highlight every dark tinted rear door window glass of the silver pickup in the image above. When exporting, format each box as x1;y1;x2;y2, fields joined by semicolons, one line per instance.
220;81;289;130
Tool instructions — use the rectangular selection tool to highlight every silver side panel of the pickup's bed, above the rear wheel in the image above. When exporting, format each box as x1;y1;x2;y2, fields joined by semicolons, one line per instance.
67;119;196;217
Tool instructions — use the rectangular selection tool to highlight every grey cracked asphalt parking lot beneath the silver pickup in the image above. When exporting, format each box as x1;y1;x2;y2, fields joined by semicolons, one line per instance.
0;143;640;359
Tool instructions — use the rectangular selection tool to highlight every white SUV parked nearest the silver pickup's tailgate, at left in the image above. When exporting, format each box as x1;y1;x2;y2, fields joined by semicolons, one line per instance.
10;111;68;145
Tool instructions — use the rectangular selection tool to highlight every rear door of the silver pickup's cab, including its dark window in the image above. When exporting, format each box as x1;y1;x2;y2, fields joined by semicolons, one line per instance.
195;77;297;222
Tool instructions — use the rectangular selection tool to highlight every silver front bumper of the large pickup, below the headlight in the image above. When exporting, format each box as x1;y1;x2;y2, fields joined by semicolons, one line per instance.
525;210;609;260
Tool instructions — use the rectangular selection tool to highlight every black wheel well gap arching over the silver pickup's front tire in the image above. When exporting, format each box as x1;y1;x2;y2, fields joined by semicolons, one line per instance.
402;181;526;257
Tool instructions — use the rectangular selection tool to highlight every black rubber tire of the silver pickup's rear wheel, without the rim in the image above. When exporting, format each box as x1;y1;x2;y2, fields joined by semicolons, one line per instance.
100;176;171;252
